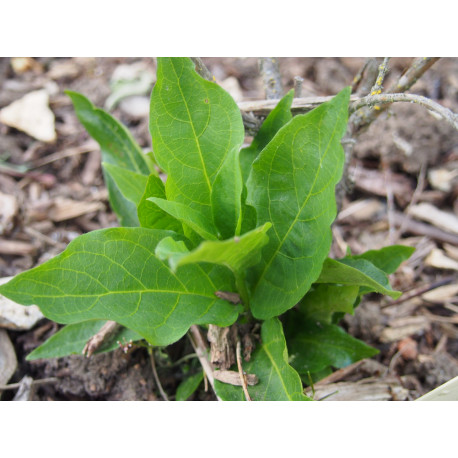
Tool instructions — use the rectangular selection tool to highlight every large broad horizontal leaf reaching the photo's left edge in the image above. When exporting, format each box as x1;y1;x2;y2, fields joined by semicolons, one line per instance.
0;228;238;346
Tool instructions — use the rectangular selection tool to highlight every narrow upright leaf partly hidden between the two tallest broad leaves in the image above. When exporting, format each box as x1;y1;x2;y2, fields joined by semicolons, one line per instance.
240;89;294;182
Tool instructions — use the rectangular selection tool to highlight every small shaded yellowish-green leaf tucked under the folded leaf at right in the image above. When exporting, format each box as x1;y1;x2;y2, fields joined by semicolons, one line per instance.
299;283;359;324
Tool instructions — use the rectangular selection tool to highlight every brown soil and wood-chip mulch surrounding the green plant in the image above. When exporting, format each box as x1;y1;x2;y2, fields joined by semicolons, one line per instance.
0;58;458;400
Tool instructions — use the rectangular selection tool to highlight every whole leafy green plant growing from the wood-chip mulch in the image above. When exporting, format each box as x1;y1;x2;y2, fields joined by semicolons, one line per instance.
0;58;412;400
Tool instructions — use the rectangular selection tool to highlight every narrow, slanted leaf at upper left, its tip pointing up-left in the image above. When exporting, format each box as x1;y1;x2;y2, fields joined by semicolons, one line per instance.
65;91;150;175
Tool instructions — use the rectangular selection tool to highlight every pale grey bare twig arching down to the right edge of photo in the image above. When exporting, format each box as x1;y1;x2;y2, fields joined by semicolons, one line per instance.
350;93;458;130
